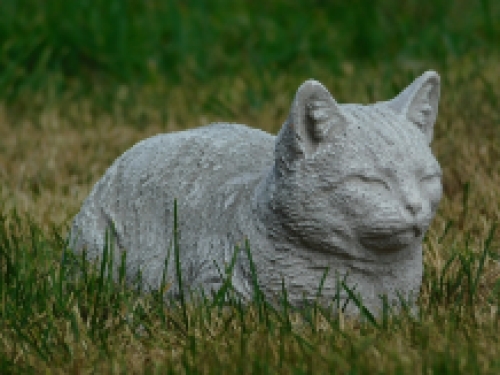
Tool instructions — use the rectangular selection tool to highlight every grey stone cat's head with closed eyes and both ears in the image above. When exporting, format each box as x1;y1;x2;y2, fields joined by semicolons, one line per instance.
271;71;442;256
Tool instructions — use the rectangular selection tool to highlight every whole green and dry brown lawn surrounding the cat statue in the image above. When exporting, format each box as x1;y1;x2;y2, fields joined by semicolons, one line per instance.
0;0;500;374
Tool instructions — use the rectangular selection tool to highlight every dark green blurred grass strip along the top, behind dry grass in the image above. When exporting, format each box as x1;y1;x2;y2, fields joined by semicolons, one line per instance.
0;0;500;100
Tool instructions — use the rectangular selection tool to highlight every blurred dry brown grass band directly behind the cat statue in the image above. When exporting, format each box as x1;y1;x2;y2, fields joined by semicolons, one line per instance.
0;59;500;242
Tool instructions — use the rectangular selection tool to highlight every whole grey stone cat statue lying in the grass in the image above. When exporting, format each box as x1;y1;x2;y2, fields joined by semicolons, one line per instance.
69;71;442;314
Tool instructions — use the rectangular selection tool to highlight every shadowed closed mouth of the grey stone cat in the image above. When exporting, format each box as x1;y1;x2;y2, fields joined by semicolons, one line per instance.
360;225;423;251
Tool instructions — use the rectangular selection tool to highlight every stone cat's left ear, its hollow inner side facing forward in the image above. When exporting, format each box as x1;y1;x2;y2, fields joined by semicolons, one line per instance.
277;80;347;157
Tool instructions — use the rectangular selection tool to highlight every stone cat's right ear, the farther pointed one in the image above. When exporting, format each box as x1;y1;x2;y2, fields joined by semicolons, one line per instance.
388;71;441;143
